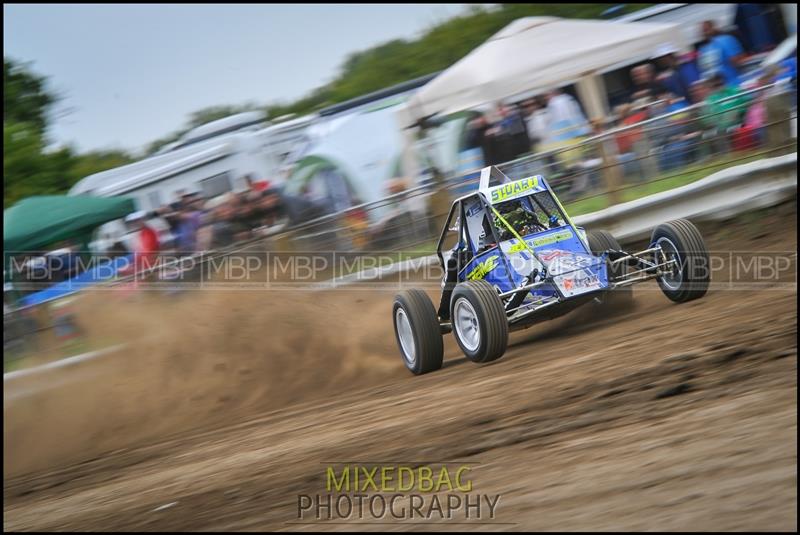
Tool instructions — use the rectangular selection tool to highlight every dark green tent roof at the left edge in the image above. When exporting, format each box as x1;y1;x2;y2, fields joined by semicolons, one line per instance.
3;195;136;253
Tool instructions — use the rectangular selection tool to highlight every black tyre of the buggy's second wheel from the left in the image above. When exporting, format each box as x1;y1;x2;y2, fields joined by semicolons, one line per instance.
450;280;508;363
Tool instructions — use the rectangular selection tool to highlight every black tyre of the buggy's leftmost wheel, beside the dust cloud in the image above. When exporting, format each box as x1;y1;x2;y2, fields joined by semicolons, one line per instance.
392;288;444;375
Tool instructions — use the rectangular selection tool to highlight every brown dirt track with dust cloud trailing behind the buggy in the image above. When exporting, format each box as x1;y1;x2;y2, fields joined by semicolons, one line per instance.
3;206;797;531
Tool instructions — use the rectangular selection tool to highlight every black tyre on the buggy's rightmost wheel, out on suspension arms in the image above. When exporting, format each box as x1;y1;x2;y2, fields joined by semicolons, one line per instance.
650;219;711;303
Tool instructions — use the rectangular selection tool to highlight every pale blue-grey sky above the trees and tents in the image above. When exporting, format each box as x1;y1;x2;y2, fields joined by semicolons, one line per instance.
3;4;476;152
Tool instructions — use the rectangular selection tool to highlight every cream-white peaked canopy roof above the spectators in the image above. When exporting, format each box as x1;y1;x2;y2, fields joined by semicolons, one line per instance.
402;17;685;126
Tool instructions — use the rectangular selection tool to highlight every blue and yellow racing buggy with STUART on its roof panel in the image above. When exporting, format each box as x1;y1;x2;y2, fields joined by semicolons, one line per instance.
392;166;710;374
